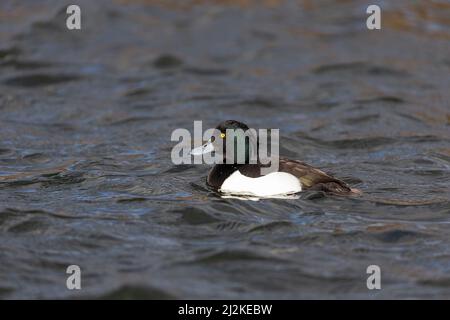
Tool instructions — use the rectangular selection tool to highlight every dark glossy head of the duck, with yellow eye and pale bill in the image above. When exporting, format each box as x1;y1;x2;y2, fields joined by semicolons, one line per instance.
191;120;257;164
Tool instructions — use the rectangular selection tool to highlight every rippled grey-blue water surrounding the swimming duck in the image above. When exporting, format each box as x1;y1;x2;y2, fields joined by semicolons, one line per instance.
0;0;450;299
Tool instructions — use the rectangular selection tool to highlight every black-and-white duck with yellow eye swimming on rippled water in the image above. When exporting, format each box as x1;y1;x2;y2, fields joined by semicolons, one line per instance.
191;120;360;197
